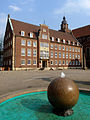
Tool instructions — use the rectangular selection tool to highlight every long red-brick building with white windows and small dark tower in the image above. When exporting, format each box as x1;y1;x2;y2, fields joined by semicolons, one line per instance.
4;15;82;70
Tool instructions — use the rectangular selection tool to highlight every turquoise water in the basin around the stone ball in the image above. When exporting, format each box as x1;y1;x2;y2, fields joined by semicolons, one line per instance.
0;91;90;120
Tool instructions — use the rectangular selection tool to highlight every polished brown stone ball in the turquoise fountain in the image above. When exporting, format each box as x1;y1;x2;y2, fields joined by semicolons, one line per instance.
47;77;79;110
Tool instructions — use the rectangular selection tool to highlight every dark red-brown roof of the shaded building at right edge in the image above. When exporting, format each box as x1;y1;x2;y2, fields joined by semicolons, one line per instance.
72;25;90;38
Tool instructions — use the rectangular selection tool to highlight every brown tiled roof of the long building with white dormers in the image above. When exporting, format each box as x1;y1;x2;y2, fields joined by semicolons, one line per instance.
11;19;76;41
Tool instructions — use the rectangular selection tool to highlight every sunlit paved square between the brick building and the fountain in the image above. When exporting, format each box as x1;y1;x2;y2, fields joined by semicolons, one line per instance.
0;69;90;96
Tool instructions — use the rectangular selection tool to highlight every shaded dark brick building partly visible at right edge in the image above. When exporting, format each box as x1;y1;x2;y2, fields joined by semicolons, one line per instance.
72;25;90;69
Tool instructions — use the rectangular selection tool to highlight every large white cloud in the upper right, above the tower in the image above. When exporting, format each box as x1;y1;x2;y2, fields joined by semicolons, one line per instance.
54;0;90;15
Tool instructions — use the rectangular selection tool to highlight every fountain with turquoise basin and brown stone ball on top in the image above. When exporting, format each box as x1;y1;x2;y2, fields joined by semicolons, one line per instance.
0;74;90;120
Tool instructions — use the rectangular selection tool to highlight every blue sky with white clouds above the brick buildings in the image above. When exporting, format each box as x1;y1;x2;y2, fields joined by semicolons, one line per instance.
0;0;90;37
